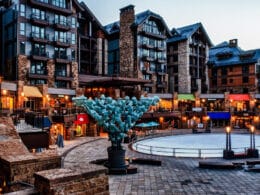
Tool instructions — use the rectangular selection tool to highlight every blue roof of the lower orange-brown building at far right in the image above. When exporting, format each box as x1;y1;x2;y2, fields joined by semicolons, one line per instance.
208;41;260;66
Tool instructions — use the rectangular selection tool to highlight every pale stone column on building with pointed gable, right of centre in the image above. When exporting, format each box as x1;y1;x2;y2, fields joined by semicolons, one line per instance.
178;41;191;93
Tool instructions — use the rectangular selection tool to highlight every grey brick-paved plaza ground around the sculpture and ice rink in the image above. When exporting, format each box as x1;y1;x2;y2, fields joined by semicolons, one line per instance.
58;130;260;195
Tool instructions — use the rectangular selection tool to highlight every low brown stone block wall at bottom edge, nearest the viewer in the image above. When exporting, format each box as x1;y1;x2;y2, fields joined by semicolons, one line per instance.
34;165;109;195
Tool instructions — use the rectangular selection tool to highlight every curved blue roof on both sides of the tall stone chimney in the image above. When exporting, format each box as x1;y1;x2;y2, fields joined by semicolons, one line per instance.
104;10;171;35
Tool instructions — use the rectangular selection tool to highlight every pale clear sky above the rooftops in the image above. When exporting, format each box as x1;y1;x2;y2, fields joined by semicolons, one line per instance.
83;0;260;50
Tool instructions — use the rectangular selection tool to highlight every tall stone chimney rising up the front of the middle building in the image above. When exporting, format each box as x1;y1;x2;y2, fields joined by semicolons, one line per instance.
119;5;135;78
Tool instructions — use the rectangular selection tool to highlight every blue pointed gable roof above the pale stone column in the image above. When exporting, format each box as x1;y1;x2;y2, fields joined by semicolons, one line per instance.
167;22;213;46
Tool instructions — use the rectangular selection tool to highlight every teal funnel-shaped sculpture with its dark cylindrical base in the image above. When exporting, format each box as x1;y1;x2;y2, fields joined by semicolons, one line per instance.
72;95;159;168
